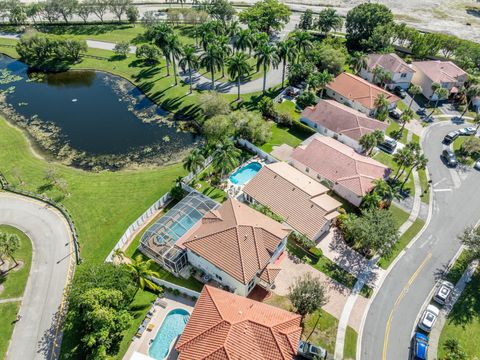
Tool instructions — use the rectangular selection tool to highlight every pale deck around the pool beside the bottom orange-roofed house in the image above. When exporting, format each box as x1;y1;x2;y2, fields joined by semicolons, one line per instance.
123;292;195;360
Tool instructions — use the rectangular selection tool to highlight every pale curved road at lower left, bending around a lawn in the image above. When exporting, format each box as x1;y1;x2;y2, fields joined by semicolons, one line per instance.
0;193;74;360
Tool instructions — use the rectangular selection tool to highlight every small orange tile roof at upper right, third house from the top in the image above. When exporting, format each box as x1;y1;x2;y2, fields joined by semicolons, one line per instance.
327;73;399;109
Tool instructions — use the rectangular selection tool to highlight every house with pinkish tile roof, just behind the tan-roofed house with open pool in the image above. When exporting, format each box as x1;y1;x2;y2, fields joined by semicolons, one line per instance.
290;134;390;206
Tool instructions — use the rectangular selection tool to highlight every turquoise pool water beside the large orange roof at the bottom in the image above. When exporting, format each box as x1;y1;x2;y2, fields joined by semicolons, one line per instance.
148;309;190;360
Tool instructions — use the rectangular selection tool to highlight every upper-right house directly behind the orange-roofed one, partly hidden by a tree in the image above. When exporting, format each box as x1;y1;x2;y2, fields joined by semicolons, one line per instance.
359;53;415;90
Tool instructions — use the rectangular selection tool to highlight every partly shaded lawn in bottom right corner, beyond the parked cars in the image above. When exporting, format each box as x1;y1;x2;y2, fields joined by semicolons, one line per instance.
438;270;480;359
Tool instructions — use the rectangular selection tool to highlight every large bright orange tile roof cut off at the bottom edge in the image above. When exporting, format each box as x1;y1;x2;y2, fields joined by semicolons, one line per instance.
175;286;302;360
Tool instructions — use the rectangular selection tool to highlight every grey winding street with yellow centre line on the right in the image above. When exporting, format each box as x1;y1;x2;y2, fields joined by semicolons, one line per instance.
360;122;480;360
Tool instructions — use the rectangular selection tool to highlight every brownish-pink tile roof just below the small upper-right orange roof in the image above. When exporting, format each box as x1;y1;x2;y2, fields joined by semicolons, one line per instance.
302;100;387;141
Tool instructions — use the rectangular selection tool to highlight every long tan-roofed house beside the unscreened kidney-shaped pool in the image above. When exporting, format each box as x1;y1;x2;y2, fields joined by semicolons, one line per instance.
243;162;342;241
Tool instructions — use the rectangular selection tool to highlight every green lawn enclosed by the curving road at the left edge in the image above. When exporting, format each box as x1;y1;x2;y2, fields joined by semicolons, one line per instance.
0;225;32;299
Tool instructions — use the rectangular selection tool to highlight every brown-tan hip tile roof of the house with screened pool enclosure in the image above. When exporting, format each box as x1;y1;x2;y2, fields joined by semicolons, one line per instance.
183;199;290;284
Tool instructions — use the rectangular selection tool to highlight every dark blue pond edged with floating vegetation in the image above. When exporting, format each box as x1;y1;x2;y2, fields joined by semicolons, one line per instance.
0;55;201;169
